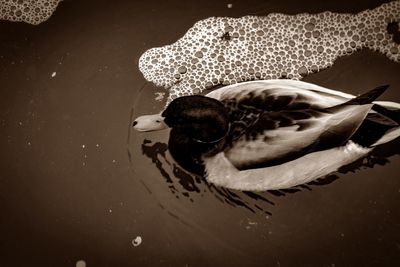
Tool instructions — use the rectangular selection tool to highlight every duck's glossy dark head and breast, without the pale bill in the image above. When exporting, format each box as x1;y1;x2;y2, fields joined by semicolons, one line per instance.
161;95;229;176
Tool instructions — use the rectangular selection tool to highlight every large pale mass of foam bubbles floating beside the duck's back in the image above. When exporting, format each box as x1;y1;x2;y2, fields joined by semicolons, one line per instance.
139;1;400;102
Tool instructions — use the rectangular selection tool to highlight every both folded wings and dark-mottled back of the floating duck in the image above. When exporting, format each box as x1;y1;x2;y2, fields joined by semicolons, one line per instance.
206;82;372;169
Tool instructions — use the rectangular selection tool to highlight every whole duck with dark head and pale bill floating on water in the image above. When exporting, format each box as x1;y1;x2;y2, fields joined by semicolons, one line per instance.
133;79;400;191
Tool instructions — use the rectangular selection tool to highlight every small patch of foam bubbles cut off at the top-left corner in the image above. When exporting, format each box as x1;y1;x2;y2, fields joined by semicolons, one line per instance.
0;0;61;25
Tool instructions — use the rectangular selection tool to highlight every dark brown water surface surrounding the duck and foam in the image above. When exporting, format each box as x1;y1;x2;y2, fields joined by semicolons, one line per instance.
0;0;400;266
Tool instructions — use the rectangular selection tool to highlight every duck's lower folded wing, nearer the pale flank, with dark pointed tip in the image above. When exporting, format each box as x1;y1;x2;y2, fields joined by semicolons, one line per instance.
225;87;387;170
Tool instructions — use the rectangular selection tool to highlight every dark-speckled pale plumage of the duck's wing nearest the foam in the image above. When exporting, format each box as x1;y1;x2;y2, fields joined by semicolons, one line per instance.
216;81;346;141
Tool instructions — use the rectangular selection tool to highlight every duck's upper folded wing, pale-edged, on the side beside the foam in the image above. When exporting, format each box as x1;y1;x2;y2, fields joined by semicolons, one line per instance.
219;80;354;144
